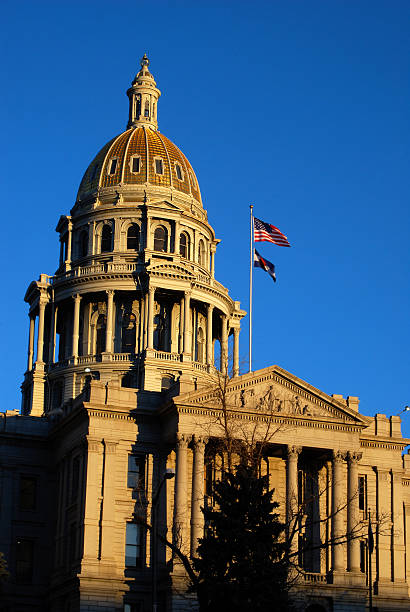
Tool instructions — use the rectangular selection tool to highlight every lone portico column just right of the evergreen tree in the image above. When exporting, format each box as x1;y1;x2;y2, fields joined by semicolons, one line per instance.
286;446;302;565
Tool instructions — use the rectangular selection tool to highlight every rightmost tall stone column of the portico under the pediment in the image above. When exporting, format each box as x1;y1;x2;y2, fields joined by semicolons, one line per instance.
347;451;362;573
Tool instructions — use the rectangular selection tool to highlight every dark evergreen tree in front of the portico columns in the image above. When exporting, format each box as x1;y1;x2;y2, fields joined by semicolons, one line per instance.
191;465;289;612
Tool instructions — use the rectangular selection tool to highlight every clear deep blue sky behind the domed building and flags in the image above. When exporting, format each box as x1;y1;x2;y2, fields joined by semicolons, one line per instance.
0;0;410;437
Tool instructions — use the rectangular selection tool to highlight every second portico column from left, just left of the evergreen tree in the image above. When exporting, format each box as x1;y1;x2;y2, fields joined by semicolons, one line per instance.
191;436;207;557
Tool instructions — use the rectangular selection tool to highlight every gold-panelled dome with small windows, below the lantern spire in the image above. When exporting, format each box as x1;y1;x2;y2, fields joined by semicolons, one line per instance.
77;125;202;206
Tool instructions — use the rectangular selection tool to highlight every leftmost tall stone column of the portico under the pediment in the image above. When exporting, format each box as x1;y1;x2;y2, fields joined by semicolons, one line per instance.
173;434;188;552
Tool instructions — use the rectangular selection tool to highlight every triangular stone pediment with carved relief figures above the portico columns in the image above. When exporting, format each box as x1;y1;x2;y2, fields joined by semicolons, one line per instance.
174;366;367;427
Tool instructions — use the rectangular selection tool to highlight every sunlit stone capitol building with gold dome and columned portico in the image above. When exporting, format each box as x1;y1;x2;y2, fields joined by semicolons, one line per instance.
0;56;410;612
